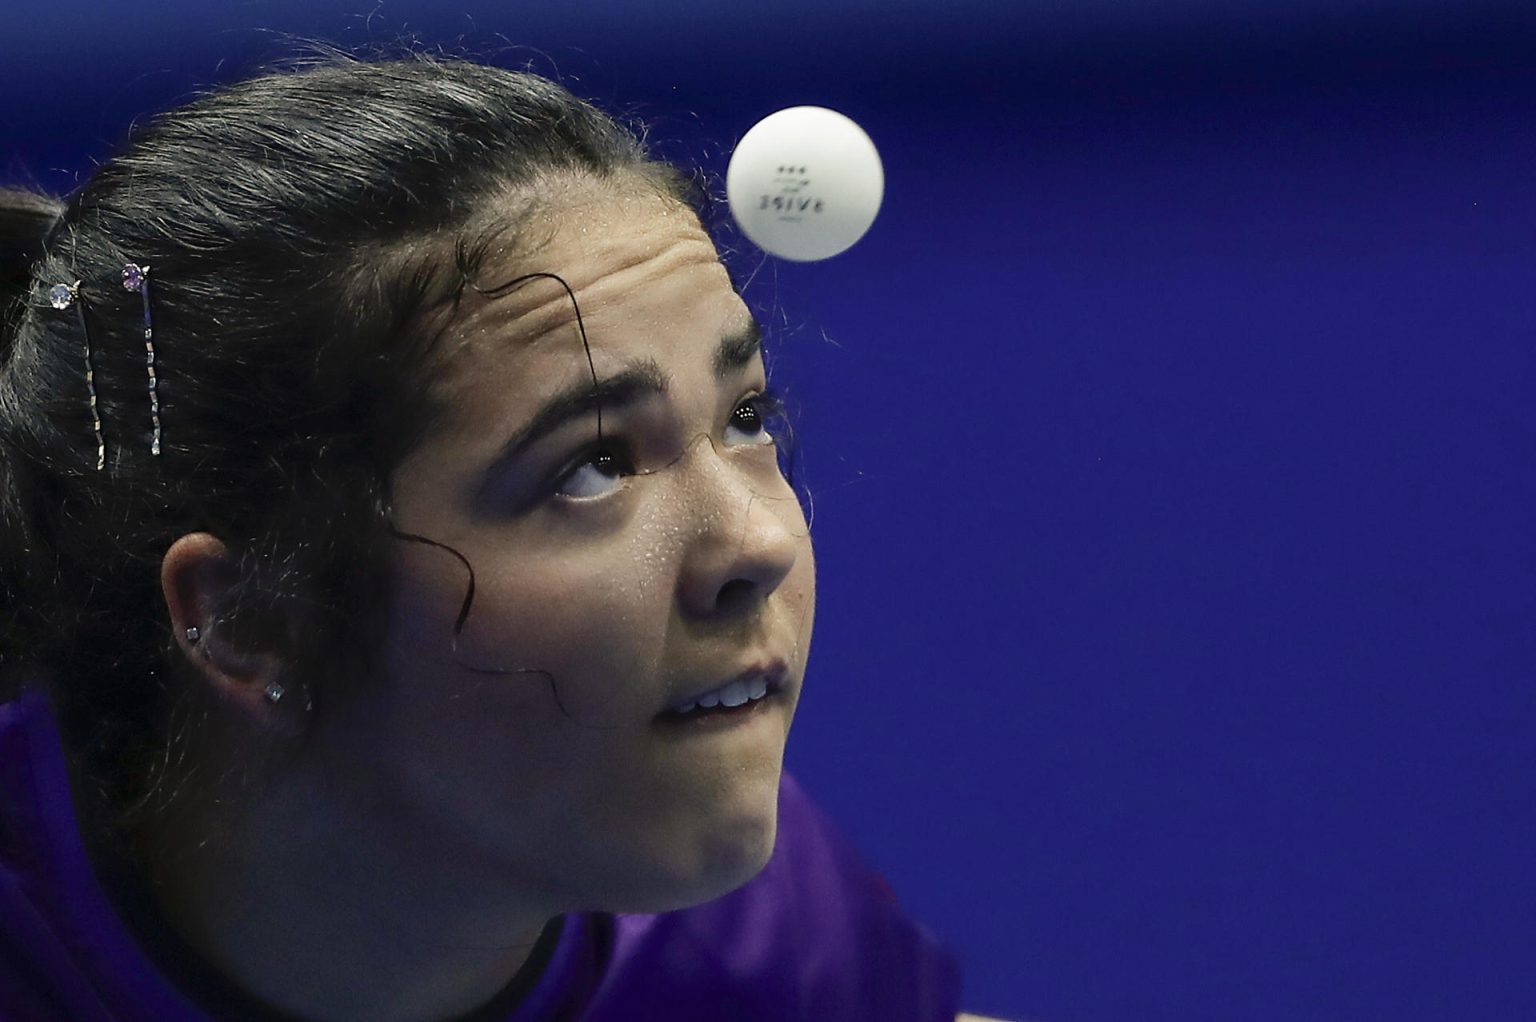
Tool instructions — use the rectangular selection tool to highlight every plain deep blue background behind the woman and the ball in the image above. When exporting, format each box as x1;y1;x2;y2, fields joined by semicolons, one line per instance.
0;0;1536;1022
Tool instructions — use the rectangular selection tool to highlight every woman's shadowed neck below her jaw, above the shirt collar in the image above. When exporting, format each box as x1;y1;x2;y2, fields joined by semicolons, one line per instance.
130;737;559;1022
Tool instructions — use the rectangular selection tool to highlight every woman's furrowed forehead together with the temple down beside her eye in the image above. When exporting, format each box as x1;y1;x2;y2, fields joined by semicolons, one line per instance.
395;183;753;526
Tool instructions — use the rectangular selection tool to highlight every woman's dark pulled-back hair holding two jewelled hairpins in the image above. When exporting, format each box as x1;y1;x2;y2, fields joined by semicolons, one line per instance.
0;57;691;854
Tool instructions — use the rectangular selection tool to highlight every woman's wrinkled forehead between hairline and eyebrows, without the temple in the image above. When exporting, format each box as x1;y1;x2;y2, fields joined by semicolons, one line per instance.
438;186;750;398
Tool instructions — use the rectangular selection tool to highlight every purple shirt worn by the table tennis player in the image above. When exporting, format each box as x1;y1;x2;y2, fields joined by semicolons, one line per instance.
0;690;960;1022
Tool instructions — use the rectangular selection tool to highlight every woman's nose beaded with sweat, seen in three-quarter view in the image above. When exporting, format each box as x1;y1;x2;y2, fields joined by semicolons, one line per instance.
680;444;803;618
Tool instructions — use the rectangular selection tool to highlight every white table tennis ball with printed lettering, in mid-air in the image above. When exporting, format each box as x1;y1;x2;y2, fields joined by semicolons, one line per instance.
725;106;885;263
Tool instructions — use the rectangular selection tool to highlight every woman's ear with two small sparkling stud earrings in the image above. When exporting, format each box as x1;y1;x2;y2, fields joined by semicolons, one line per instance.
160;532;309;736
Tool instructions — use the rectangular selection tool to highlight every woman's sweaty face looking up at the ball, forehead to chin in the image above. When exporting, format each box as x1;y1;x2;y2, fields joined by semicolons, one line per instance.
338;189;816;911
